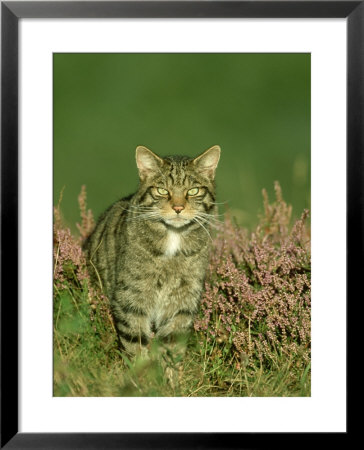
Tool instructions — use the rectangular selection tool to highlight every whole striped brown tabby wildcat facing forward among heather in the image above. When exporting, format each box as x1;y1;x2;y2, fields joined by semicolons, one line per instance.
84;146;220;355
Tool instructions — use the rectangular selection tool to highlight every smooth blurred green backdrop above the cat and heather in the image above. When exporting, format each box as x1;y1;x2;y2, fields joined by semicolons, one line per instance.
53;53;310;230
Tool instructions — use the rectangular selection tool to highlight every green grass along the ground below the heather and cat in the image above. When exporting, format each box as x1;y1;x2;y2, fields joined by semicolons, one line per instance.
54;256;310;397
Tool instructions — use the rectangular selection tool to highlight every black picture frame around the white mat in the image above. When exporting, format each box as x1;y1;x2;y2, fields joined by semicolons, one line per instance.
0;0;358;449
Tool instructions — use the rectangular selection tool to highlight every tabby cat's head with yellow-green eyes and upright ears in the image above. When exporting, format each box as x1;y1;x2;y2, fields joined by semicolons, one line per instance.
136;145;220;228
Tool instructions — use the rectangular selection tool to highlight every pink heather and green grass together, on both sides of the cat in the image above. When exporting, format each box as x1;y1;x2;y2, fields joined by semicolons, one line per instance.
54;183;310;396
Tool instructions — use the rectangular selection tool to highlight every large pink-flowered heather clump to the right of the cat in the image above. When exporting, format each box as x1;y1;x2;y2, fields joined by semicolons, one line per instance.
194;183;311;370
